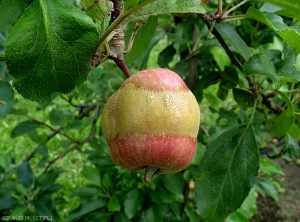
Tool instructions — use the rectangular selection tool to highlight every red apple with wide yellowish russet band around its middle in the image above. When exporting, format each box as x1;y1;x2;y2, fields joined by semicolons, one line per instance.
102;68;200;181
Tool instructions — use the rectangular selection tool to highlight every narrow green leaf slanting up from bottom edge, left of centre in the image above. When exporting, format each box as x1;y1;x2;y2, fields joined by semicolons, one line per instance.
66;199;106;222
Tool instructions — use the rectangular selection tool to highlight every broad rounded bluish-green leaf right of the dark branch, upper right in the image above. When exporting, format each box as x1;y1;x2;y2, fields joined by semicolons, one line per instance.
244;54;279;81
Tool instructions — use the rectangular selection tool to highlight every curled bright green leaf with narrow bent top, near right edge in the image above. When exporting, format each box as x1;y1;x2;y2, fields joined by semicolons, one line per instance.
270;91;295;137
